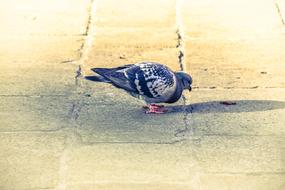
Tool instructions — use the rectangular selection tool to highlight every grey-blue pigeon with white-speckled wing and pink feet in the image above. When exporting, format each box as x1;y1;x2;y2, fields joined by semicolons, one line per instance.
85;62;192;114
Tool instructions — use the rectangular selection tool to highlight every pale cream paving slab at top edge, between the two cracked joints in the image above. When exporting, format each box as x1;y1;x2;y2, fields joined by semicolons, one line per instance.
96;0;175;27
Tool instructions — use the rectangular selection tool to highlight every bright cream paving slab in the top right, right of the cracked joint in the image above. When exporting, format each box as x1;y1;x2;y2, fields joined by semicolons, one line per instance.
180;0;283;39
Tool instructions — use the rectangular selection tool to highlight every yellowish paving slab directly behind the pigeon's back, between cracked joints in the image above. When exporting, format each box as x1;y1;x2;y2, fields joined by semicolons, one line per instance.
84;46;180;71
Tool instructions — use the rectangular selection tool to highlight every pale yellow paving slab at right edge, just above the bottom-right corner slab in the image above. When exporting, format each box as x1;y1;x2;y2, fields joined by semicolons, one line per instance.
184;135;285;175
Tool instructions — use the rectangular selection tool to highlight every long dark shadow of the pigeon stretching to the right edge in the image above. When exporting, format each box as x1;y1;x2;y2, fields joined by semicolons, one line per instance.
168;100;285;114
